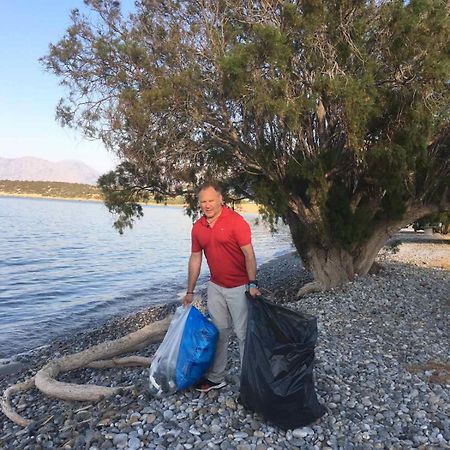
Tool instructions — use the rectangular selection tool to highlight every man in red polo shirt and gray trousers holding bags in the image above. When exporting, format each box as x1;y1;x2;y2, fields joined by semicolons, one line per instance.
183;183;261;392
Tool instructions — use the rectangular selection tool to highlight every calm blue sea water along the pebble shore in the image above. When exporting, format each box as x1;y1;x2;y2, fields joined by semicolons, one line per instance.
0;197;291;359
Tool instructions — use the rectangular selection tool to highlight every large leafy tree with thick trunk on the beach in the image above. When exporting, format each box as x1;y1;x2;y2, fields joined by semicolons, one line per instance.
43;0;450;288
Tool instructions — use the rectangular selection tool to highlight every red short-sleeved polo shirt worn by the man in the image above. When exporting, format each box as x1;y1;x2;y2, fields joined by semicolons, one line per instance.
192;206;252;288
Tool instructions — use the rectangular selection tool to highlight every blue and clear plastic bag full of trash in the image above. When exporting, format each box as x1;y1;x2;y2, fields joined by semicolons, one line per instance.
149;306;219;396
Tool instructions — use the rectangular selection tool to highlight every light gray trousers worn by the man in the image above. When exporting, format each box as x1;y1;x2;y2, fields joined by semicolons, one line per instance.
206;281;248;383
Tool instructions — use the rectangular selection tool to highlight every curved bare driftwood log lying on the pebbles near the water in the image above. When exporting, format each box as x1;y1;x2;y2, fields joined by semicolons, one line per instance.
0;315;172;427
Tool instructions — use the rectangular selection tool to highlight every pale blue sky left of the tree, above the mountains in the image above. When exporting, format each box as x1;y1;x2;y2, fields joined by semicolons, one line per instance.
0;0;132;172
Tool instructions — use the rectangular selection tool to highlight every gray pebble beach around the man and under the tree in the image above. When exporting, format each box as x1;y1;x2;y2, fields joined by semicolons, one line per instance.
0;237;450;450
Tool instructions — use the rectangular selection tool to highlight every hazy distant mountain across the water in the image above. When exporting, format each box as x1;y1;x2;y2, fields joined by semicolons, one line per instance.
0;156;100;185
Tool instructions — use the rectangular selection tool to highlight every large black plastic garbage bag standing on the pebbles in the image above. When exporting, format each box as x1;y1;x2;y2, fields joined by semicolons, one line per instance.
240;297;325;430
